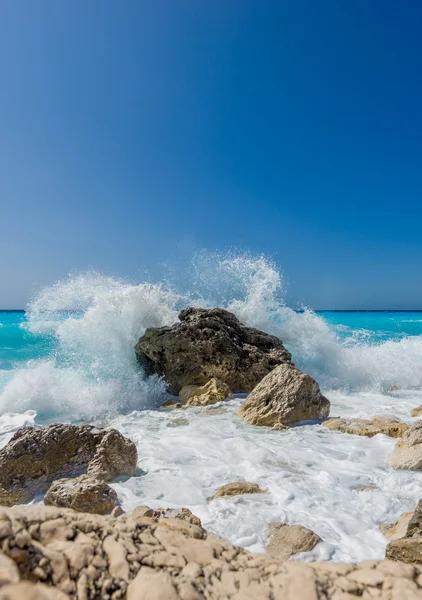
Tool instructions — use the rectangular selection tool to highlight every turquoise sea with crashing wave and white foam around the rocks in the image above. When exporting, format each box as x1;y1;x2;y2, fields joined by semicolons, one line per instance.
0;255;422;561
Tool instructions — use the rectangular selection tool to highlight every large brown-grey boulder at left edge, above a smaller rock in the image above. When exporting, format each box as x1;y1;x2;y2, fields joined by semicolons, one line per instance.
0;424;137;506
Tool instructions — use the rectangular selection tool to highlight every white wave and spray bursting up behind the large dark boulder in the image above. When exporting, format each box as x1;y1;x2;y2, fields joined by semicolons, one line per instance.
0;253;422;418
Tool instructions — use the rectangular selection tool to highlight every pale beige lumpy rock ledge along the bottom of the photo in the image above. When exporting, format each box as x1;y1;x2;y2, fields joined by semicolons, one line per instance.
0;507;422;600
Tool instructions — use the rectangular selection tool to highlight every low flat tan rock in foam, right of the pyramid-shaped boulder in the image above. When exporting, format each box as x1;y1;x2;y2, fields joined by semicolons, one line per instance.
323;415;409;438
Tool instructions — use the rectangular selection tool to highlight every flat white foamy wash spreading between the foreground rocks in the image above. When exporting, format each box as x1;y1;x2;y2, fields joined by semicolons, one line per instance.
111;392;422;561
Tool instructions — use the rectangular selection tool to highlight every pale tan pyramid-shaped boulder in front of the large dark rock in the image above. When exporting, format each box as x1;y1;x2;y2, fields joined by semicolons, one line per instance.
239;364;330;427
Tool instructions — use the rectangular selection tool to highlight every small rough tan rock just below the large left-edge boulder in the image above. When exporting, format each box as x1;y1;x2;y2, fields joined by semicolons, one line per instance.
44;475;119;515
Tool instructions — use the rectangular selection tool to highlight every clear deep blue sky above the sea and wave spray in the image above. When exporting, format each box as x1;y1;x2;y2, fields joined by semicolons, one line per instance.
0;0;422;308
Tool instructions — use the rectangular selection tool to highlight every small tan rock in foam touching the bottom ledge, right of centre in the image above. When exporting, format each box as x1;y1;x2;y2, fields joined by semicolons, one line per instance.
267;523;322;559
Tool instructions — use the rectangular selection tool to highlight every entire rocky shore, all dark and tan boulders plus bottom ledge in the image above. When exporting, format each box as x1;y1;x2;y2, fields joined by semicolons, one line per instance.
0;308;422;600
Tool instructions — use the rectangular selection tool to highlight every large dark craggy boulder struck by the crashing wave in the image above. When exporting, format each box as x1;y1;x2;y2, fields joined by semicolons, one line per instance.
135;308;292;394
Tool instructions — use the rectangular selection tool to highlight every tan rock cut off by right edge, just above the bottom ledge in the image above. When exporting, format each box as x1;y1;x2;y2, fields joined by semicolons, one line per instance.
385;500;422;564
